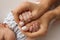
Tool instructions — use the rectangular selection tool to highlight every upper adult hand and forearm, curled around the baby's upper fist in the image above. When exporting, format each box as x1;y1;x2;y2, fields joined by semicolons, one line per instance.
12;0;56;24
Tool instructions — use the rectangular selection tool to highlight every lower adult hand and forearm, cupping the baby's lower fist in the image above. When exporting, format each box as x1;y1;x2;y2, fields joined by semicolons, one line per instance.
22;6;60;38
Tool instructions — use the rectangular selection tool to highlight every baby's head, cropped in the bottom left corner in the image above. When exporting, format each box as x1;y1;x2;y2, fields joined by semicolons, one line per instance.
0;23;16;40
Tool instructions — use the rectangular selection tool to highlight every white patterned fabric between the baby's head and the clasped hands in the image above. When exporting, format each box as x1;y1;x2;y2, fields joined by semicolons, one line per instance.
3;12;26;40
